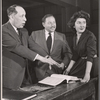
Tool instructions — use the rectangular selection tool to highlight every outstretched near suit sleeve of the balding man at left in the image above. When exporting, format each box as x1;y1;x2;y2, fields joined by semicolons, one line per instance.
2;29;37;60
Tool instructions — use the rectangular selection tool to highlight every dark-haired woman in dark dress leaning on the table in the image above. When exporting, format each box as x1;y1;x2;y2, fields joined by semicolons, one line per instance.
64;11;97;82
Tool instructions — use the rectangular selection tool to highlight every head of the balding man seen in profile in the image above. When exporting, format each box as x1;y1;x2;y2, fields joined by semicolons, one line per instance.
7;5;26;28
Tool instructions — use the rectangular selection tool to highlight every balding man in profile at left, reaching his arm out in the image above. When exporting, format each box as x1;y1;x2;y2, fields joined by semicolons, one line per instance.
2;5;57;89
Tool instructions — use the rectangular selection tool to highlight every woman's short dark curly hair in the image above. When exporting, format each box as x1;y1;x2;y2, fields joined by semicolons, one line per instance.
67;10;90;31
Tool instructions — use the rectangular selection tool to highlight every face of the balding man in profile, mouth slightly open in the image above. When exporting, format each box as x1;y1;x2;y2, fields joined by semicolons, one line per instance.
12;7;26;28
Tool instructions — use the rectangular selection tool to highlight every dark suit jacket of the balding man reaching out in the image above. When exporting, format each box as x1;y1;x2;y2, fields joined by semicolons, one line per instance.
2;22;43;89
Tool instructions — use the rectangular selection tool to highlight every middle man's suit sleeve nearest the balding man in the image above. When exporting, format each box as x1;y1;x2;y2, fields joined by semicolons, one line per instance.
29;32;47;57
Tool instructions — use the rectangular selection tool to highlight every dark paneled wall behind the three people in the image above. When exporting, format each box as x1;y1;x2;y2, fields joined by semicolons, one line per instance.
2;0;99;52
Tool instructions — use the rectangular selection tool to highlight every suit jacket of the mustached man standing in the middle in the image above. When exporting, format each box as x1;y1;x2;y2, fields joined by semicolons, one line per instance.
29;30;71;80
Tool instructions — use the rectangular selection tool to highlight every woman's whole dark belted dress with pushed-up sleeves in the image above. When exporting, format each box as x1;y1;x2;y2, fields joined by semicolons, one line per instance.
69;30;98;78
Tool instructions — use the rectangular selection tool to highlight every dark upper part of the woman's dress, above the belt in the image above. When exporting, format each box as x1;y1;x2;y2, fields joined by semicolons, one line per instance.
72;30;97;62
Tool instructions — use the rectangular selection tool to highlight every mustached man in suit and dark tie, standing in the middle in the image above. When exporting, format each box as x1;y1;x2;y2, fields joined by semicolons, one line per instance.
29;14;72;80
